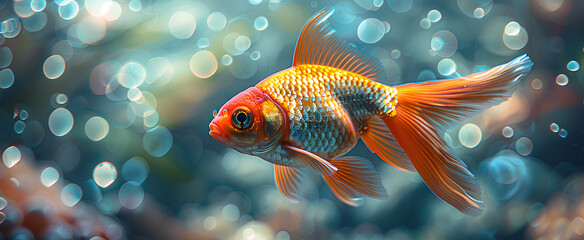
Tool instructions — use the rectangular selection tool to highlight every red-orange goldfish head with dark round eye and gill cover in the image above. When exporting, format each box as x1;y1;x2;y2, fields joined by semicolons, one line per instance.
209;87;286;155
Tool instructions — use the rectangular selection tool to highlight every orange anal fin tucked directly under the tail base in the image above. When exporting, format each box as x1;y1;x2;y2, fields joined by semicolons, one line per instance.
361;116;416;172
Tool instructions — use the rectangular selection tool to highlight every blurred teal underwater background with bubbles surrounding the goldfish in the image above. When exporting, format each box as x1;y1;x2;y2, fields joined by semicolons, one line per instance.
0;0;584;240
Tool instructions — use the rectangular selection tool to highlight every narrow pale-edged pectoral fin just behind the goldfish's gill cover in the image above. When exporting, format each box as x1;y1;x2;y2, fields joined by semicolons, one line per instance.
283;145;338;176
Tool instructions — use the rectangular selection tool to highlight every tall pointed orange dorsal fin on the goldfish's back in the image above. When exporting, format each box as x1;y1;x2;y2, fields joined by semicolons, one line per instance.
293;6;387;81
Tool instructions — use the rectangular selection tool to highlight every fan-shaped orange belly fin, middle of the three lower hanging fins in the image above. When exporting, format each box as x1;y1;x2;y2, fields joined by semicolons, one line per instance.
329;157;389;199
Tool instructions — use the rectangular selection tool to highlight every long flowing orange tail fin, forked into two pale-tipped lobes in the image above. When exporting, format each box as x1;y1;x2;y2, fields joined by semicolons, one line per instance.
383;55;533;216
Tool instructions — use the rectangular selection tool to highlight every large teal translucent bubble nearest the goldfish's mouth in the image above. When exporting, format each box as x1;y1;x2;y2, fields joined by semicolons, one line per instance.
142;125;172;157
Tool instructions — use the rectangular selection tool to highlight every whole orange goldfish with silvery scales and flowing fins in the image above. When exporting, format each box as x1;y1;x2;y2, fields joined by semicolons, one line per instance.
209;7;533;216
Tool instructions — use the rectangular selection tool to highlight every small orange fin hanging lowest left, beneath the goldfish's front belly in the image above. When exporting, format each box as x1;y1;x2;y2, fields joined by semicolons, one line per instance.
274;165;304;203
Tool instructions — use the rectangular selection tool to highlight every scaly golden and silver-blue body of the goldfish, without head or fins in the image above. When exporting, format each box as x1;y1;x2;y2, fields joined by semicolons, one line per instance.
256;65;397;159
